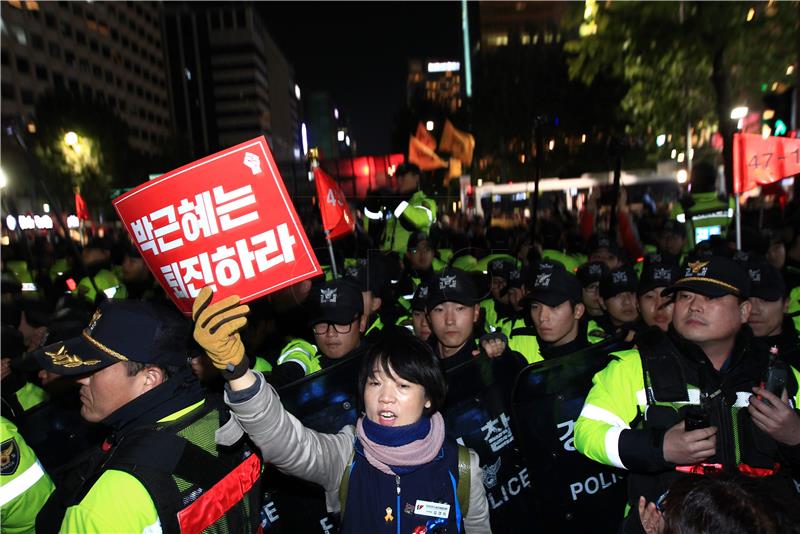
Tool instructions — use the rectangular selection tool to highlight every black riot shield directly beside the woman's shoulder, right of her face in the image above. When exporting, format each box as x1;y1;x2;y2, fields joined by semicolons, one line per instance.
442;356;535;534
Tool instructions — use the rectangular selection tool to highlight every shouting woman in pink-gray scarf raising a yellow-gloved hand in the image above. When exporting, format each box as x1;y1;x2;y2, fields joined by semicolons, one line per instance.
192;288;491;534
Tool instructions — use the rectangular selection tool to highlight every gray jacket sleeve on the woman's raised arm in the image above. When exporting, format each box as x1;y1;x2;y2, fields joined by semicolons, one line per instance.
217;373;354;512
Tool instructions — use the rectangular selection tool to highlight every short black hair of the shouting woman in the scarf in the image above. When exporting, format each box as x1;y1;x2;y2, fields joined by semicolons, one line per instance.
358;326;447;415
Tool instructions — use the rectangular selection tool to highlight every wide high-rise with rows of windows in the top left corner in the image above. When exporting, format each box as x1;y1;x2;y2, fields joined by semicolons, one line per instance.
0;0;171;153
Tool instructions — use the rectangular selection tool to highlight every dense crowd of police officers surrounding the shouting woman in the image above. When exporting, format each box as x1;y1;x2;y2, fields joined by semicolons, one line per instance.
0;163;800;534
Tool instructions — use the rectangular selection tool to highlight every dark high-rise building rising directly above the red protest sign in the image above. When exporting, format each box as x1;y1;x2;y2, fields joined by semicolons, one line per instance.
164;2;302;160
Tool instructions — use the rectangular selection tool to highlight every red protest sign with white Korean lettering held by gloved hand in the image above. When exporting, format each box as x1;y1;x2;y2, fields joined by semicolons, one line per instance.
114;136;322;315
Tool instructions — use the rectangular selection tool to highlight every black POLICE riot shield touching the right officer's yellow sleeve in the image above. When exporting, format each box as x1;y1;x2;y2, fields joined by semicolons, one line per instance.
512;342;626;533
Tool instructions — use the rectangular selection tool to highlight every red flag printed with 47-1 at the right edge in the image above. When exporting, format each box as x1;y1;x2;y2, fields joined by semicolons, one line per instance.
733;133;800;193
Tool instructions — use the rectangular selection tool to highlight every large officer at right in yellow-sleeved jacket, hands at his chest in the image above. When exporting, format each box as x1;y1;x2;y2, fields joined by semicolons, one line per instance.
575;256;800;532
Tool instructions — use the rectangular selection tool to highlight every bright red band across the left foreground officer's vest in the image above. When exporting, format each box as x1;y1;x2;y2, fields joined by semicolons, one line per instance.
178;454;261;534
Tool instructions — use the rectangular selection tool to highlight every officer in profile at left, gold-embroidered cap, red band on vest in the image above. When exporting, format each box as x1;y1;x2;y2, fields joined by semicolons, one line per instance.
36;304;261;532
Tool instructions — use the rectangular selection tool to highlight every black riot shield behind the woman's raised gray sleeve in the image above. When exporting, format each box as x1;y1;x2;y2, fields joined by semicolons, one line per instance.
261;358;361;534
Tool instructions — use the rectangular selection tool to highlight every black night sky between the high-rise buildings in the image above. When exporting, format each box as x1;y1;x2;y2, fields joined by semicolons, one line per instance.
259;1;463;155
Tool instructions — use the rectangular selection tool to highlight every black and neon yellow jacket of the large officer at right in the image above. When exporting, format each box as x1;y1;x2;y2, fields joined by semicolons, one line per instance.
575;325;800;531
